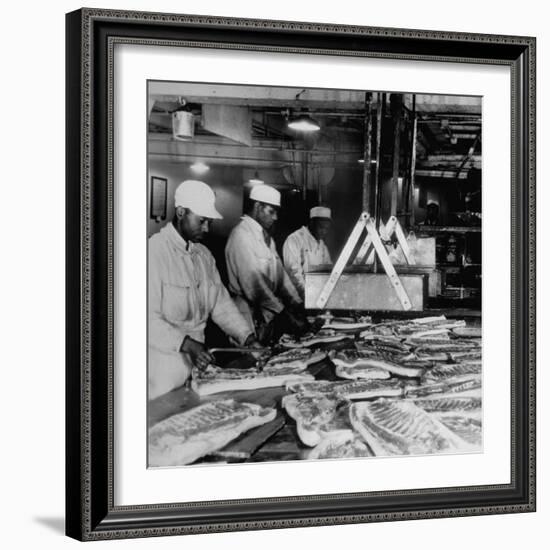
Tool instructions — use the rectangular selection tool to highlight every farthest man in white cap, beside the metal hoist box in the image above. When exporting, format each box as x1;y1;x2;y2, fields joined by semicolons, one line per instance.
283;206;332;297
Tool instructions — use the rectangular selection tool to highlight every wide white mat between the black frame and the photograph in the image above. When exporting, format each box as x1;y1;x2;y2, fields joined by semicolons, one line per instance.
113;45;511;506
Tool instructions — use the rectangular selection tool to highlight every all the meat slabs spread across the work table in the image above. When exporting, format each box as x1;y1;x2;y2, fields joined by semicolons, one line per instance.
149;316;482;466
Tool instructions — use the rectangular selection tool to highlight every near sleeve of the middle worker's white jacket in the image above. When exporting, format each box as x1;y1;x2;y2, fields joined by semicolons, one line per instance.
225;236;286;316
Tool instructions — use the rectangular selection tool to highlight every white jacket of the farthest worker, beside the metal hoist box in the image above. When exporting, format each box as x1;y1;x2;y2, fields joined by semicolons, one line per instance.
283;227;332;296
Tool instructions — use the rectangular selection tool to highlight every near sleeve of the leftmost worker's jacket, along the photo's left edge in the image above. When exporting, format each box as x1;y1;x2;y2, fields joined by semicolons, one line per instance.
148;246;189;352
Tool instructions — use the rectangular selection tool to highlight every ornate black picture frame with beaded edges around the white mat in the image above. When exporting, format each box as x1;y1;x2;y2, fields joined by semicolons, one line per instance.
66;9;535;540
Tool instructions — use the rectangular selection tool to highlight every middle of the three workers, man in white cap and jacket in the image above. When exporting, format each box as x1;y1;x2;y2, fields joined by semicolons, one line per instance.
225;185;307;344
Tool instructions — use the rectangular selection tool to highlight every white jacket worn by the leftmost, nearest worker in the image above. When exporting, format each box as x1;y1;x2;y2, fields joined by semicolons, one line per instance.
148;223;253;399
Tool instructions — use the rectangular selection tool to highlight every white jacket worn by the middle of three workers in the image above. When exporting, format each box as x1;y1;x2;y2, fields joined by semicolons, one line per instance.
225;216;302;323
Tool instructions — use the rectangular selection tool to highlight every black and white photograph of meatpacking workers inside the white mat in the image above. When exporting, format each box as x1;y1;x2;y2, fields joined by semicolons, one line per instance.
146;80;484;468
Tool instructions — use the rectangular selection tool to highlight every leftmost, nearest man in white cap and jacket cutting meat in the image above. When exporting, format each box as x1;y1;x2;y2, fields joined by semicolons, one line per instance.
148;180;258;399
